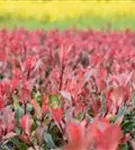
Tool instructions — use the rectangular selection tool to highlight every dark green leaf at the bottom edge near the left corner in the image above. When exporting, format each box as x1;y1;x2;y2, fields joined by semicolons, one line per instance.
10;137;27;150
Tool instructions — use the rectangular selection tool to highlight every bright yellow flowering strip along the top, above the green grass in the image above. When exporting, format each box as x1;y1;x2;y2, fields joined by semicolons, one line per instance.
0;0;135;22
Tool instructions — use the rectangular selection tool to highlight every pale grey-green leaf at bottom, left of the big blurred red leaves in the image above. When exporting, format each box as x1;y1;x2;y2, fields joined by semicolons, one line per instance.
44;132;56;148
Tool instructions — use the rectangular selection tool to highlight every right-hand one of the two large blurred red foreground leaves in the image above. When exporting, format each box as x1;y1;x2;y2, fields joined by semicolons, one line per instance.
91;120;123;150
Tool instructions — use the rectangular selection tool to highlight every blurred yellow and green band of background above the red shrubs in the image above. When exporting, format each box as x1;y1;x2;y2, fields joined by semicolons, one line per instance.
0;0;135;30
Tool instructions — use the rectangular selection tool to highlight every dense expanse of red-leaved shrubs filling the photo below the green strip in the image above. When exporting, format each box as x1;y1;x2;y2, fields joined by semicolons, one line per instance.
0;28;135;150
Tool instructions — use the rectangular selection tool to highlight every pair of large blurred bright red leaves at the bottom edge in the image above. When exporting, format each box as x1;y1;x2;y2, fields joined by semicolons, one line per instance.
65;119;123;150
